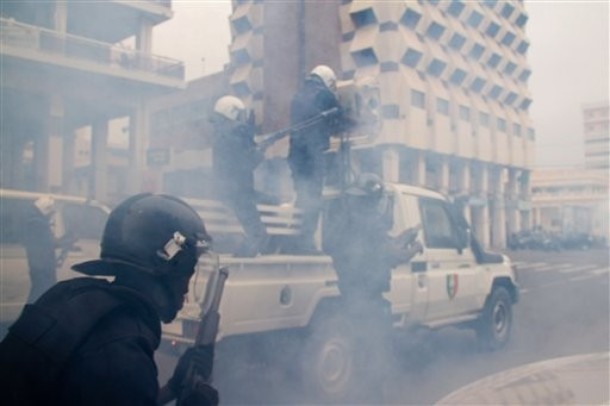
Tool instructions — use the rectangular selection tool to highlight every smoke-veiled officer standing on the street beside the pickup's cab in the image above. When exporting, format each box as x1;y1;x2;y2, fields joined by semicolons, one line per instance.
325;173;423;396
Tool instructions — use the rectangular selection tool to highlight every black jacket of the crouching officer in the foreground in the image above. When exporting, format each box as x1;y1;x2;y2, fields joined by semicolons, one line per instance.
0;278;161;405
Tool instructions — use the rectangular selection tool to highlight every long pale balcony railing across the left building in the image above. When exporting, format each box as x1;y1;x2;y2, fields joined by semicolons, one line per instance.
0;18;184;80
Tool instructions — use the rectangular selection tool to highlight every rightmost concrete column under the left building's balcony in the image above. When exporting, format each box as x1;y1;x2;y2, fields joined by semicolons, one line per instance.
128;104;148;194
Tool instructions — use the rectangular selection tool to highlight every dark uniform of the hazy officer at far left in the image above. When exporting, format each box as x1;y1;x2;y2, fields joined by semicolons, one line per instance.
23;206;57;303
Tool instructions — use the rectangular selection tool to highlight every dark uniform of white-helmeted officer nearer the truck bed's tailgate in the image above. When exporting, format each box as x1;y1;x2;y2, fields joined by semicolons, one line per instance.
212;125;268;255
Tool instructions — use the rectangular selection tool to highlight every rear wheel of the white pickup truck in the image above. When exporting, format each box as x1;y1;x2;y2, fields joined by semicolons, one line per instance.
301;316;356;402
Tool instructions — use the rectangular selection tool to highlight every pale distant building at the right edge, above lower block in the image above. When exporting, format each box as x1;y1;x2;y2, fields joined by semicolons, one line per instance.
582;100;610;177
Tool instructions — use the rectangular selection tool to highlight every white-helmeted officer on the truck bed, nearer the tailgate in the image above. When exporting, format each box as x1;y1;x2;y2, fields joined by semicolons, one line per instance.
211;96;269;257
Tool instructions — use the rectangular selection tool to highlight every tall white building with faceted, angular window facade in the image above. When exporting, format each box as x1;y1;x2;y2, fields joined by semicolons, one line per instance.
217;0;534;247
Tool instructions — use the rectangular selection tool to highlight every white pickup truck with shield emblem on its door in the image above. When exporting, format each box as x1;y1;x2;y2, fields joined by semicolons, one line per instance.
164;184;519;400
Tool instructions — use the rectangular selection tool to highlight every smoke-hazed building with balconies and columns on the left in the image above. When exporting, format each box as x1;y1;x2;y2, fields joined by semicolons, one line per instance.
0;0;185;200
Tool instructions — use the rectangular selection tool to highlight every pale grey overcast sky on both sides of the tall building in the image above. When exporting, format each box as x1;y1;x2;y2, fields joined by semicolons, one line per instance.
153;0;610;167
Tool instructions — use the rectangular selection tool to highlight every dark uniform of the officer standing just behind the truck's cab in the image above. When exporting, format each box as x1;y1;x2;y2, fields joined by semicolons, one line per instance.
288;78;341;250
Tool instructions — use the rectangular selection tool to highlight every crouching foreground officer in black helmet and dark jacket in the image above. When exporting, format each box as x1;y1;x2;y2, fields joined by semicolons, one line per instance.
0;194;218;405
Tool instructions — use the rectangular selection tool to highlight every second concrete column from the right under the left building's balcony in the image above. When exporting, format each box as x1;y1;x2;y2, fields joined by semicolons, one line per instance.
89;119;108;202
